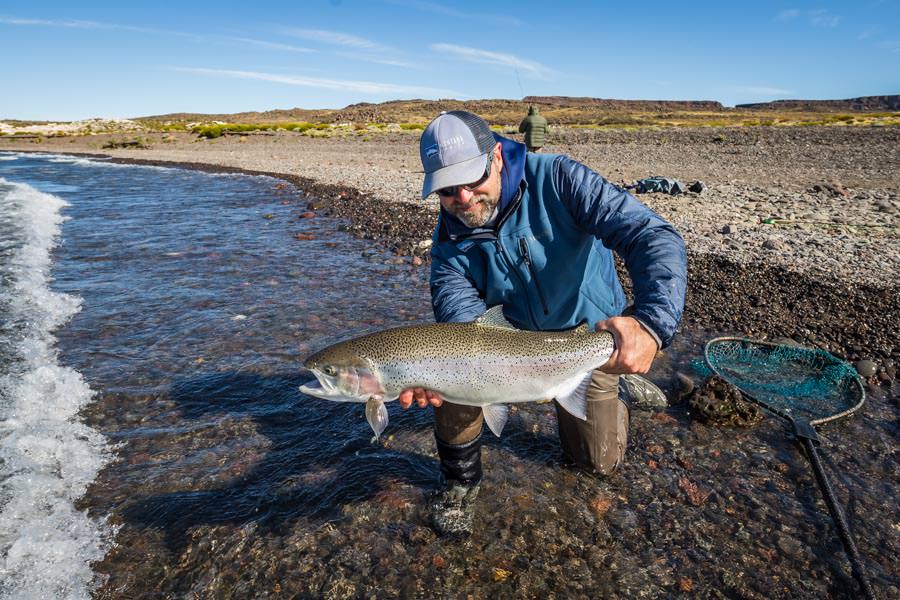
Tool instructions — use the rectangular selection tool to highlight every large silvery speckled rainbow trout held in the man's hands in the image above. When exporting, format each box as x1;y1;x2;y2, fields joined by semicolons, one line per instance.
300;306;614;438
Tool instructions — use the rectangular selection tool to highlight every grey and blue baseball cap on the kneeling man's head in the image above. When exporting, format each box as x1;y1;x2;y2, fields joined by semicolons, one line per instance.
419;110;497;198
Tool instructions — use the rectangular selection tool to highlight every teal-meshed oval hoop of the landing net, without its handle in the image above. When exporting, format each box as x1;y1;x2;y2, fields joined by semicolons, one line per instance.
705;338;865;424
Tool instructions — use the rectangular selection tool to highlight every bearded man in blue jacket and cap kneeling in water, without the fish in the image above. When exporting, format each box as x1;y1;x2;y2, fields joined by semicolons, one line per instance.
399;111;687;535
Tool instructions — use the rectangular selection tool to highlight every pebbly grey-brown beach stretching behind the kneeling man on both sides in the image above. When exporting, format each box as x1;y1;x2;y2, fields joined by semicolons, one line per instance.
0;127;900;380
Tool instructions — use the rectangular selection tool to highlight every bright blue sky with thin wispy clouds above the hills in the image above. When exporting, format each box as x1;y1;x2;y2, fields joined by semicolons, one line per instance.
0;0;900;120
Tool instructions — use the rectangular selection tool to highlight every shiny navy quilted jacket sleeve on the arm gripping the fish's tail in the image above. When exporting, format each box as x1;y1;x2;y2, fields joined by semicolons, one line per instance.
554;156;687;347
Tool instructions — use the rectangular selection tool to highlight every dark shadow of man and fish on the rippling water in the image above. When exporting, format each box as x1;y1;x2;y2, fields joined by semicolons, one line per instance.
120;372;436;550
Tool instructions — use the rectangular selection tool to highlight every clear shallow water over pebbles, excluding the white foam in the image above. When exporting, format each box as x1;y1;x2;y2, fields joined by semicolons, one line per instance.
0;155;900;598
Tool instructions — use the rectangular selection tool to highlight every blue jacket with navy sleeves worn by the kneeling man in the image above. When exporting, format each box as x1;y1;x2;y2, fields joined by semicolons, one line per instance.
431;136;687;347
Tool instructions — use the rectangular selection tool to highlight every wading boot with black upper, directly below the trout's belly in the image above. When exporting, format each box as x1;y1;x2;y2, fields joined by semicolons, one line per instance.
430;435;481;538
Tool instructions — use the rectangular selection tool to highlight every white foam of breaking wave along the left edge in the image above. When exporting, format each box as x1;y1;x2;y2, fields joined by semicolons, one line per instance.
0;178;115;600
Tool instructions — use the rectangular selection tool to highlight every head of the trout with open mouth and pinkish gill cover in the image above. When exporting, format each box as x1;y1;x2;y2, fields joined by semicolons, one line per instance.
300;344;384;402
